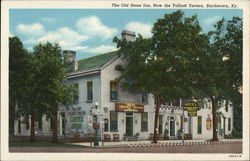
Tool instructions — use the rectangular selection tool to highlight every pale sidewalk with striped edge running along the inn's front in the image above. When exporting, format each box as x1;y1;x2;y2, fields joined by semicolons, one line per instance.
68;139;242;148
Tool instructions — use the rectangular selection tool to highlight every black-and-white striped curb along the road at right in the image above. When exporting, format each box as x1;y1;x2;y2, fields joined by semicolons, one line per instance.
129;141;242;147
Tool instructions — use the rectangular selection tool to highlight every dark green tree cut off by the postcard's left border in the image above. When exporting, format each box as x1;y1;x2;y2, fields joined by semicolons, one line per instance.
9;36;31;133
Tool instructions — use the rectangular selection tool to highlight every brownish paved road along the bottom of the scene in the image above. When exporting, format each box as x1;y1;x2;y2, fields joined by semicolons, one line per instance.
9;144;242;153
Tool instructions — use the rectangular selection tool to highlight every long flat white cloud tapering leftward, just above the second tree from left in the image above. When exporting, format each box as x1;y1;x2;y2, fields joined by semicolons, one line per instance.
24;27;88;49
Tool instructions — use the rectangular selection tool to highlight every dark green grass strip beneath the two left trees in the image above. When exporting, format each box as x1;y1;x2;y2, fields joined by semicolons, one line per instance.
9;141;86;148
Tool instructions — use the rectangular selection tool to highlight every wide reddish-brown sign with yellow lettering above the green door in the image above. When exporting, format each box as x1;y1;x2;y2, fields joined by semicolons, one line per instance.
115;103;144;112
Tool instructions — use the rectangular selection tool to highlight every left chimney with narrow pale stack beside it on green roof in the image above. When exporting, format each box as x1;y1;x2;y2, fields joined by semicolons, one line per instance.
63;50;78;71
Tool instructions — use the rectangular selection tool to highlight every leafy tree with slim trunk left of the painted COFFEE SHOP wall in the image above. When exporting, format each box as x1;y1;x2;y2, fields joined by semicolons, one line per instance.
32;42;71;142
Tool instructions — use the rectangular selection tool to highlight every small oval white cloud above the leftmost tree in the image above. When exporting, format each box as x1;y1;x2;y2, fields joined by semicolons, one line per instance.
16;23;45;36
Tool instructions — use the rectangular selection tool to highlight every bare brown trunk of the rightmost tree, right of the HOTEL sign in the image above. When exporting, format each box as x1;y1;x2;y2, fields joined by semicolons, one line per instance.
211;97;218;141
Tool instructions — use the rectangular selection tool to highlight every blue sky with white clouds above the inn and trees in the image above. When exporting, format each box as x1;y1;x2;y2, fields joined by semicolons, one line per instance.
9;9;242;60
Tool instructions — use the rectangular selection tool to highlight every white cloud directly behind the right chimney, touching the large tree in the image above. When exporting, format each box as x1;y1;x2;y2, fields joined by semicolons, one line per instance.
125;21;153;37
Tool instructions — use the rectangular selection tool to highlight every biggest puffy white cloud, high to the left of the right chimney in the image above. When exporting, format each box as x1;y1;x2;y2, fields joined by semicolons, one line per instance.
76;16;118;40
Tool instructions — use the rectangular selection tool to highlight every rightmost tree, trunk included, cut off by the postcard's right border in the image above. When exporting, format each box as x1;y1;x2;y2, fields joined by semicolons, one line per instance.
191;18;242;141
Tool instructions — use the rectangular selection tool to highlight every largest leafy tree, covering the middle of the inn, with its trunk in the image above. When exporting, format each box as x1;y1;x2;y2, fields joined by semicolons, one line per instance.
114;11;208;143
